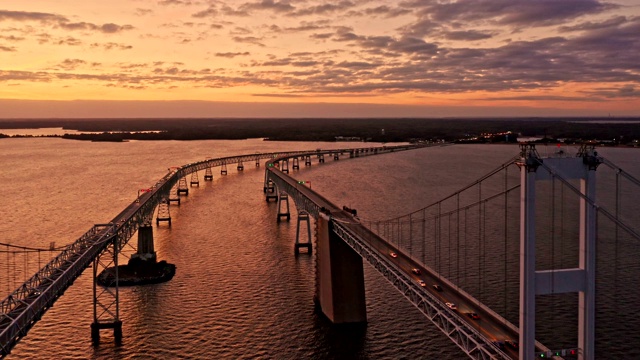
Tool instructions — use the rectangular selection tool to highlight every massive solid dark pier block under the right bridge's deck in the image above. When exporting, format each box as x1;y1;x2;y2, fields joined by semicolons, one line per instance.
316;214;367;324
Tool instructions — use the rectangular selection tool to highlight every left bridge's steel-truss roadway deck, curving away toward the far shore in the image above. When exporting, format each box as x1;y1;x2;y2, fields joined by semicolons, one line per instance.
0;145;421;358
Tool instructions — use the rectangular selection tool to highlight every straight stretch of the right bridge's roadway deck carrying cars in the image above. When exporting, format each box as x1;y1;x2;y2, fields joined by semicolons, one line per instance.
265;152;549;359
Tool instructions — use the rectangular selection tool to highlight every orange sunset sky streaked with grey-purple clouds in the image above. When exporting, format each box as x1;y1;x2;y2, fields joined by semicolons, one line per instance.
0;0;640;117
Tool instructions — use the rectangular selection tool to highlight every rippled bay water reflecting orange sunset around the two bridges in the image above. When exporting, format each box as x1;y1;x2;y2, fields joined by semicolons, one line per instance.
0;139;640;359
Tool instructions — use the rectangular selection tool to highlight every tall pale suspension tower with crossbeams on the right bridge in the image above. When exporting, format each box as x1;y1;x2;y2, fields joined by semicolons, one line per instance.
518;144;601;360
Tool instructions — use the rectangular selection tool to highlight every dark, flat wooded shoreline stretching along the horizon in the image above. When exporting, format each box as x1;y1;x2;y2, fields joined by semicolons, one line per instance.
0;118;640;142
